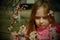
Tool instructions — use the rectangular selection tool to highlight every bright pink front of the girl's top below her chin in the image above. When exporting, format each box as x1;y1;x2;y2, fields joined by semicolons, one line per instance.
37;27;50;40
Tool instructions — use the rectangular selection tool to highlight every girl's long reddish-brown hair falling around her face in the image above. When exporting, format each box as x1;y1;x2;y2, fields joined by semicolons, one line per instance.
27;0;55;39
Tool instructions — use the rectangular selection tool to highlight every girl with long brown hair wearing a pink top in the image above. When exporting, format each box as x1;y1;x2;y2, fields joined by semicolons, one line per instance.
25;0;60;40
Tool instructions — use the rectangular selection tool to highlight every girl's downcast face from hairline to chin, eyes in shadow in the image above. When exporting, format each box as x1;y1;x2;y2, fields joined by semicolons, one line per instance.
35;7;49;28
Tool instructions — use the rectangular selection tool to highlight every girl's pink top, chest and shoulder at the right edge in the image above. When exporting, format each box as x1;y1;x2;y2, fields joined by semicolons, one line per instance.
37;25;60;40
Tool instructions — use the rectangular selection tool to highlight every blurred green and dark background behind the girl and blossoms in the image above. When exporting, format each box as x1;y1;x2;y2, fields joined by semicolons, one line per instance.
0;0;60;40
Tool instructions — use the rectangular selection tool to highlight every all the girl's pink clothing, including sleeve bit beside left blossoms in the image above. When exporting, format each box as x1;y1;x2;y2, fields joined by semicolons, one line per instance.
17;25;60;40
